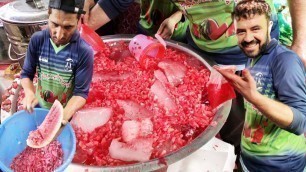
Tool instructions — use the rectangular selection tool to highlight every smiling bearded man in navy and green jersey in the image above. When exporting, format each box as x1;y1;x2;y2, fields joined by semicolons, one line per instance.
214;0;306;172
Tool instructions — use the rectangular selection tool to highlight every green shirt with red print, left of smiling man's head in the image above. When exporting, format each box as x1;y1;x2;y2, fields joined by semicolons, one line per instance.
175;0;275;52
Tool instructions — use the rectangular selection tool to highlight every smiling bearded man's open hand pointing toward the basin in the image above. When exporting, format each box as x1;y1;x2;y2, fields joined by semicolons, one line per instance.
214;66;260;103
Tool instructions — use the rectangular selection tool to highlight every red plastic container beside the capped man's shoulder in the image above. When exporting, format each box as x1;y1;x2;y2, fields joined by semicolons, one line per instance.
79;24;105;51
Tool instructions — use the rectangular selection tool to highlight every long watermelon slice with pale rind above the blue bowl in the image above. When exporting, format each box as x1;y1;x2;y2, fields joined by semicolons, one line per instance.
27;100;64;148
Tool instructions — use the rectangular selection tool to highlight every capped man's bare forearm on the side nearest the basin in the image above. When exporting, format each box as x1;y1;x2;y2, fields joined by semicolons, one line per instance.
64;96;86;121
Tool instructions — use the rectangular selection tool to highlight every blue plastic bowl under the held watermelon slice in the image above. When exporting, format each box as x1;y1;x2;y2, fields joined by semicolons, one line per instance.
0;108;76;172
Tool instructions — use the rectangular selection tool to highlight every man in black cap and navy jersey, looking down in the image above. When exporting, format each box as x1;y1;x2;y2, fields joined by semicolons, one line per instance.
21;0;93;123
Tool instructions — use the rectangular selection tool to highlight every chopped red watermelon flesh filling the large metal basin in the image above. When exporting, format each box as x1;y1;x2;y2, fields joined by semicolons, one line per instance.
73;43;215;166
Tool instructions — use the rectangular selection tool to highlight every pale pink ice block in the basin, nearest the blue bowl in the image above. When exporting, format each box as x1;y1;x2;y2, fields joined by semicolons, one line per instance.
71;107;112;132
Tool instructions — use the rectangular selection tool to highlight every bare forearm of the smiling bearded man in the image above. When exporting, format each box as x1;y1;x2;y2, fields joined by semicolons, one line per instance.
248;92;293;128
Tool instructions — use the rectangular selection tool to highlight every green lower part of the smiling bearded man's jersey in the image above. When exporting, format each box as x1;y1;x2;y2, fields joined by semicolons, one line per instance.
241;101;306;156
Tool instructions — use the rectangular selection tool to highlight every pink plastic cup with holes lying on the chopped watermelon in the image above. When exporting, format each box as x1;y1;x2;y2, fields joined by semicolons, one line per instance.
129;34;166;68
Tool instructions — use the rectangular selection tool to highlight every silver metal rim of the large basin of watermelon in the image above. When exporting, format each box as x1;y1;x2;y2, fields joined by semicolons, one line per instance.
67;35;232;172
